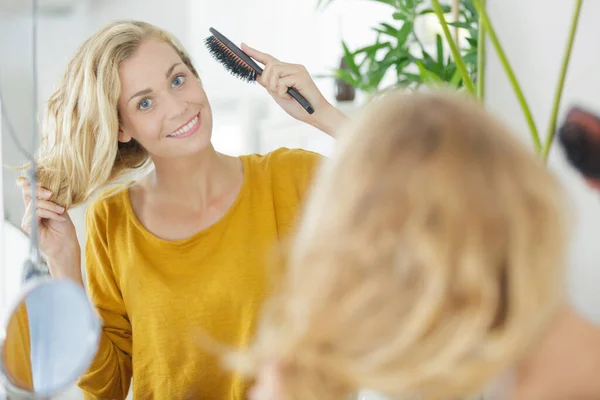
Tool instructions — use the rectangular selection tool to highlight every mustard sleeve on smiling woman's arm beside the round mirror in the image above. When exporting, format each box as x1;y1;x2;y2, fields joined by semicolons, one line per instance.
79;203;132;400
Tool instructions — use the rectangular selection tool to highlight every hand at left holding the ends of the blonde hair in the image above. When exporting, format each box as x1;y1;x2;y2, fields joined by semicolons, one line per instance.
19;179;82;283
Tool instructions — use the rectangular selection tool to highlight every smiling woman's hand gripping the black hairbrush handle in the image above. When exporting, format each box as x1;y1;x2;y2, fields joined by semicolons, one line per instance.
242;44;347;136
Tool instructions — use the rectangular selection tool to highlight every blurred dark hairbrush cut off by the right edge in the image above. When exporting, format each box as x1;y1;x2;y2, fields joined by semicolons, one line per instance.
558;107;600;188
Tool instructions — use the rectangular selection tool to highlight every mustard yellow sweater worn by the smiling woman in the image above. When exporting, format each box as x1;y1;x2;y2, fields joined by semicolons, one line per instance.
79;149;320;400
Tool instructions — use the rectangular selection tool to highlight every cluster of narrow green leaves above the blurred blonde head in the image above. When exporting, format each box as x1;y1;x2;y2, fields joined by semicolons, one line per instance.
318;0;479;93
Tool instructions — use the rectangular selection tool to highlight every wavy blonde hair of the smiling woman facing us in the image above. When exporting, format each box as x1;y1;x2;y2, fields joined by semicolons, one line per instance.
21;21;199;207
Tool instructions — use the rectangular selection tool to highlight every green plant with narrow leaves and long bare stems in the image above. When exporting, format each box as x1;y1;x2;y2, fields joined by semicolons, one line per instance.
317;0;583;161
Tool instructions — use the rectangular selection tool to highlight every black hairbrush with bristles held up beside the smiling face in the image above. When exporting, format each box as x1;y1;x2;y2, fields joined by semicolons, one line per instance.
204;28;315;114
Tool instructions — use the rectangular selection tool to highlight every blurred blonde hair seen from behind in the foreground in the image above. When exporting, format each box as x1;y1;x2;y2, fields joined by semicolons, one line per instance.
238;93;565;400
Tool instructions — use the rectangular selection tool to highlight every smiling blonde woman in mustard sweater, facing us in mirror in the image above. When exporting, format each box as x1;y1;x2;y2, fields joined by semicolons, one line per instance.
17;21;345;400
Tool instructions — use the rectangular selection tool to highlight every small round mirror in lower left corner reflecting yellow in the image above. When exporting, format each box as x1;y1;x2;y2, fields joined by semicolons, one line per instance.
0;279;101;397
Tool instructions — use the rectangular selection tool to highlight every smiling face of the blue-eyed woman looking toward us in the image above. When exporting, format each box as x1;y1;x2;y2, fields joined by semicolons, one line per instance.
118;40;212;159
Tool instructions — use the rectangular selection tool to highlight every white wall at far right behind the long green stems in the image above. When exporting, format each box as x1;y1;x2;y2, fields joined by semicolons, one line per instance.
486;0;600;322
